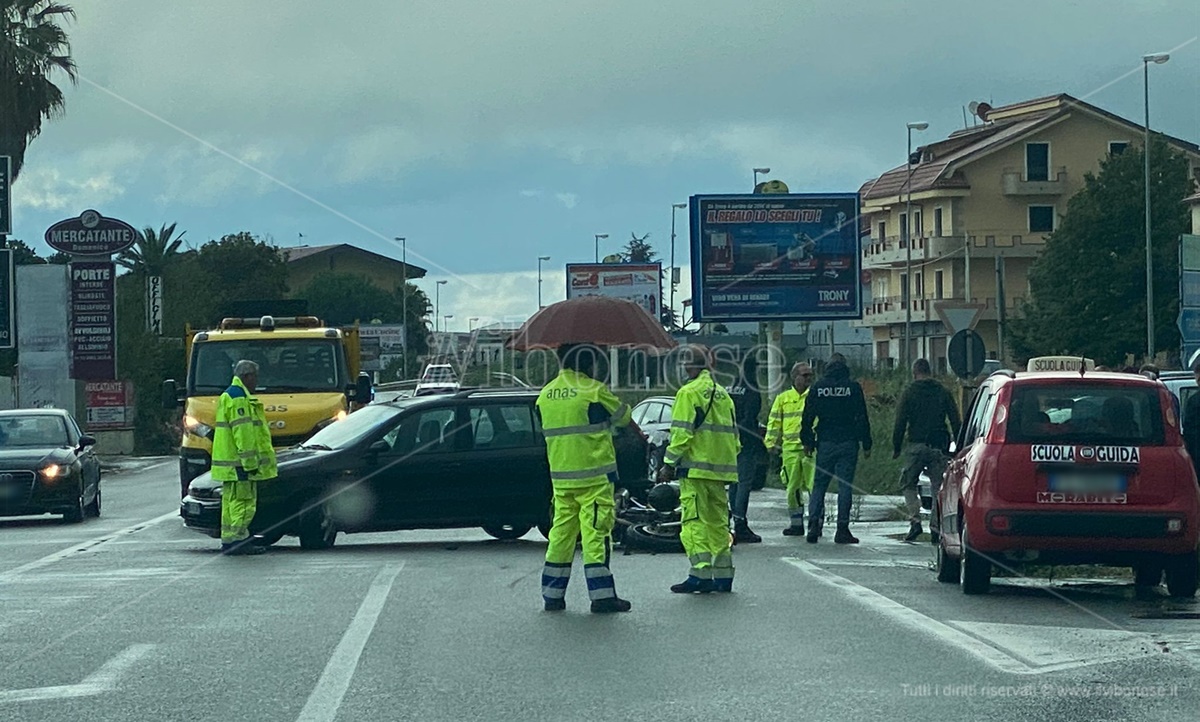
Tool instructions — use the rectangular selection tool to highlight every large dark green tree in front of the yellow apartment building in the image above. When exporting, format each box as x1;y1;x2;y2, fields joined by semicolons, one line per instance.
1008;137;1194;363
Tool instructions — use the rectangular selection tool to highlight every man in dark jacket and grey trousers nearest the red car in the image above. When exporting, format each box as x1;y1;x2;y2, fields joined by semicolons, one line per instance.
892;359;962;541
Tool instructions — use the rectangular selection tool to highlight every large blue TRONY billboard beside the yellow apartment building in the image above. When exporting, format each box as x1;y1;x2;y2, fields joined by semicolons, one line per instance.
690;193;863;321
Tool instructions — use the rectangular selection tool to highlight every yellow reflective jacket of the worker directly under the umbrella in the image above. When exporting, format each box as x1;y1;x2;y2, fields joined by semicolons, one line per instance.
538;368;630;488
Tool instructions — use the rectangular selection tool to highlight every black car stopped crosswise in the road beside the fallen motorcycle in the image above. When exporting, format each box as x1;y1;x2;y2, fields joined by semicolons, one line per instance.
180;390;647;549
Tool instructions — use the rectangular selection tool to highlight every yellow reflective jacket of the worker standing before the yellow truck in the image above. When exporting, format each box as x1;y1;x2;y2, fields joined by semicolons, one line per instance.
212;377;277;481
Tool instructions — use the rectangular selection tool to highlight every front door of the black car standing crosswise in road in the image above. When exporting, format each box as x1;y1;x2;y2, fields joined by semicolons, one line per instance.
367;404;467;529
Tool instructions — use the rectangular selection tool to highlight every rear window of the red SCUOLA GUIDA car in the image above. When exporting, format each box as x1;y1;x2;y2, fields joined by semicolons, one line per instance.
1006;384;1163;446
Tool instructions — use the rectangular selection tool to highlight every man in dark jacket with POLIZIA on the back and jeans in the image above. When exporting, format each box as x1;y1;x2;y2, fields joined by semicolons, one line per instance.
800;354;871;544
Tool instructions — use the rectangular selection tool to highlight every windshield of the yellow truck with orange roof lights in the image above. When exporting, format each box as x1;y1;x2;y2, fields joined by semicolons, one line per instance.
187;338;349;395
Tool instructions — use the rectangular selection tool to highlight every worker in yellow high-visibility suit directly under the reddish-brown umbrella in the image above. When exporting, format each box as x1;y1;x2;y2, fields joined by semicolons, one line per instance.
538;345;631;613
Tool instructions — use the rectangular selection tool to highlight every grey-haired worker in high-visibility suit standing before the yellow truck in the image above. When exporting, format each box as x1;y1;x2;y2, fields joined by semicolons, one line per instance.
212;360;276;555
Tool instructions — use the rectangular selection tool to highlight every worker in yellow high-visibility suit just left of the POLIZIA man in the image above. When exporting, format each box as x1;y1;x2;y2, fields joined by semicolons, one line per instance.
766;362;817;536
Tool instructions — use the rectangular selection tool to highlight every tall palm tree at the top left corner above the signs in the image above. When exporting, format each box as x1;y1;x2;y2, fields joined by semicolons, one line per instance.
0;0;77;179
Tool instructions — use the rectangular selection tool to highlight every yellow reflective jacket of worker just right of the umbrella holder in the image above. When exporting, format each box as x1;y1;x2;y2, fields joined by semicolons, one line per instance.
662;371;742;483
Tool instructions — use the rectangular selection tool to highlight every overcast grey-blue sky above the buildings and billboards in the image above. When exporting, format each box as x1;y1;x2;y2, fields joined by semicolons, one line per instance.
13;0;1200;329
